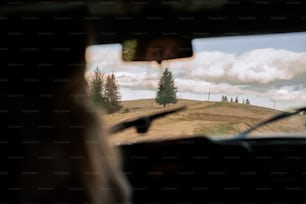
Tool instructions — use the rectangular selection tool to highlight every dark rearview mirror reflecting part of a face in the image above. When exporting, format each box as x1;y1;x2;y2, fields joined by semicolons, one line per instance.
122;37;193;63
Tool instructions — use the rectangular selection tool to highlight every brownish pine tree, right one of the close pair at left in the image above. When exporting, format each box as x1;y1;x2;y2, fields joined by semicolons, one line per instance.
105;74;121;113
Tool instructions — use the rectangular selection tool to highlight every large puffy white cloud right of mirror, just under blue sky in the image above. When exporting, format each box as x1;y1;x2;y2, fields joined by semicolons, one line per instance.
171;48;306;84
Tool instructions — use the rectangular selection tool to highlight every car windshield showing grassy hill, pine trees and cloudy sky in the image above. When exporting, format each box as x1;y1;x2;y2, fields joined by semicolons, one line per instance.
86;33;306;144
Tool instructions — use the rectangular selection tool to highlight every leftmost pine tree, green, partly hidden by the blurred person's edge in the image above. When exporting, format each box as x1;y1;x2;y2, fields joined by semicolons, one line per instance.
89;67;106;108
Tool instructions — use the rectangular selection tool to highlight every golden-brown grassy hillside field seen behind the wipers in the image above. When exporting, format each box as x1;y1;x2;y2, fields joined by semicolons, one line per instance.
103;99;306;144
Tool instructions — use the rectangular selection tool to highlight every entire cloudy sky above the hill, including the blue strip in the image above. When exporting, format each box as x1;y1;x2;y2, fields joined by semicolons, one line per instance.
86;33;306;110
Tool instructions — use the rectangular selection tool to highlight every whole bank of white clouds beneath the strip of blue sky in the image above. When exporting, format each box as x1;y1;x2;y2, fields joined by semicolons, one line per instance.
86;47;306;107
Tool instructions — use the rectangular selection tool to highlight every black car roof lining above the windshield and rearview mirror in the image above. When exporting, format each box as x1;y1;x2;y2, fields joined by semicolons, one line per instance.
0;0;306;44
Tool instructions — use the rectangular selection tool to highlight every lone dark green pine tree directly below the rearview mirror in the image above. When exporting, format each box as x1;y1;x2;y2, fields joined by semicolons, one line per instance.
155;68;177;107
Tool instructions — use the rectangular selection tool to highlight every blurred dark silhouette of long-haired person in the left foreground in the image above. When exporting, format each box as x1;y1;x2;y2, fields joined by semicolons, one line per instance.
0;5;129;204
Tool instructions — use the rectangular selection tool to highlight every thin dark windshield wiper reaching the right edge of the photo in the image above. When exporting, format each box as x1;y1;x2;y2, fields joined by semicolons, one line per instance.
235;107;306;139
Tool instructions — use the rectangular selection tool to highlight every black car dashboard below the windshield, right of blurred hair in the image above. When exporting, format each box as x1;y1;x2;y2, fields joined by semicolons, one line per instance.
120;136;306;204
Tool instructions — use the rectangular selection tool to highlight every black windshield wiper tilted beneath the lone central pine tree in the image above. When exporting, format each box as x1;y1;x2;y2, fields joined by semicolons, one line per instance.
110;106;186;134
